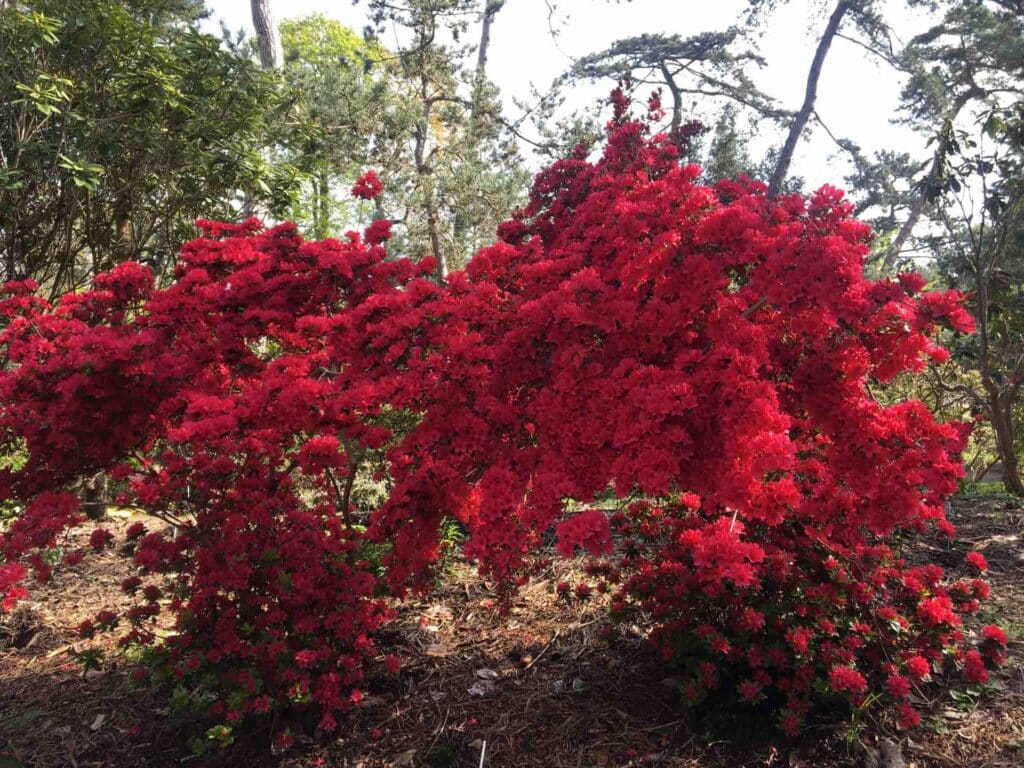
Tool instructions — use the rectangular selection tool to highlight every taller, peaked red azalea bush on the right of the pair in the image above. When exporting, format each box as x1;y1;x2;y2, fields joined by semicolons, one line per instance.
370;91;1002;731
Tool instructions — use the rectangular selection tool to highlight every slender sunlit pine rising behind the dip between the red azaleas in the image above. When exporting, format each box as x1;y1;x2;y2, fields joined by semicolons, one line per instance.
369;0;527;278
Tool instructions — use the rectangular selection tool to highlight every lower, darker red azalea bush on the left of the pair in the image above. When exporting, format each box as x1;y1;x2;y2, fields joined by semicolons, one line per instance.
0;214;438;730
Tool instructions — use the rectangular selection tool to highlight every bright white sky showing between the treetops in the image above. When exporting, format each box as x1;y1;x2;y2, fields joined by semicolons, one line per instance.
201;0;942;188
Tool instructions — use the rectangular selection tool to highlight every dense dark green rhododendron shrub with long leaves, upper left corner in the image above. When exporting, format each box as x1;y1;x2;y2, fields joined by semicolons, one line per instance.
0;0;299;294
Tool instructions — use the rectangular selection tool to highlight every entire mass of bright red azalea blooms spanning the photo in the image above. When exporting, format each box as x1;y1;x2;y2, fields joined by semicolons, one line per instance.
0;94;1006;741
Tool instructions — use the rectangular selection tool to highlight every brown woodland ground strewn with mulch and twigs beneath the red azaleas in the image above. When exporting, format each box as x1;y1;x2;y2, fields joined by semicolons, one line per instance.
0;496;1024;768
